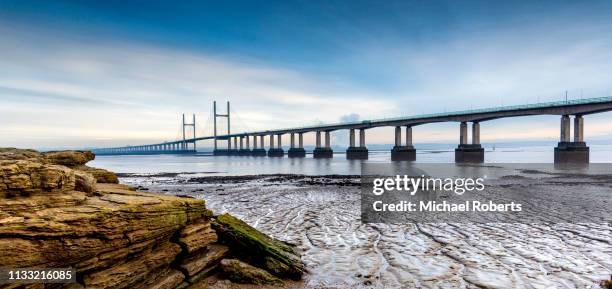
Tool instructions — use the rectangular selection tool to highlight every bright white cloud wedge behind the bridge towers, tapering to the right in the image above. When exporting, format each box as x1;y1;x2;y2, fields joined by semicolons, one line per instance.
0;25;394;147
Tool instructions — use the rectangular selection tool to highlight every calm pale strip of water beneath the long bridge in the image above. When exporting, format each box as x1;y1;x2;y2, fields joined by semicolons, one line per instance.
90;145;612;175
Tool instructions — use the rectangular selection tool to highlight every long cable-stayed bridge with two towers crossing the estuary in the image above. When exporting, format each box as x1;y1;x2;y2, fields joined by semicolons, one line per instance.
93;96;612;163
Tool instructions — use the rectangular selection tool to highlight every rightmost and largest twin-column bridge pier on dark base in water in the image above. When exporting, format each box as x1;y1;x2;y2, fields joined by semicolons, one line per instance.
554;115;589;164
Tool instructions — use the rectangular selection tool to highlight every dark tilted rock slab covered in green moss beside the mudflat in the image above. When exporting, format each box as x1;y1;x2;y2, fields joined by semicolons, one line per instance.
213;214;304;280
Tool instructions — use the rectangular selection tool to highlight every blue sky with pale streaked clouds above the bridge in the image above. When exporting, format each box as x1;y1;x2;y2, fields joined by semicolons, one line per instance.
0;0;612;149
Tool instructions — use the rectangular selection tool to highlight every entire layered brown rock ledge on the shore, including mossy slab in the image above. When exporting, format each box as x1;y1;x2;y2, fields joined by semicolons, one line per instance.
0;148;304;289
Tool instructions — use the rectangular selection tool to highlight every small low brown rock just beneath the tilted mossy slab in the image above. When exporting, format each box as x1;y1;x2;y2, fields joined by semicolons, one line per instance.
220;259;284;286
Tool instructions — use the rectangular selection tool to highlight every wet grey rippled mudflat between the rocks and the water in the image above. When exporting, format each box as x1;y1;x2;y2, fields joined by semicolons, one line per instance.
122;176;612;288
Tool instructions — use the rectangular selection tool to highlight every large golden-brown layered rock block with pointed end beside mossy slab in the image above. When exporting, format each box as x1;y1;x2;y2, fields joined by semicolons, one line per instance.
0;180;211;269
